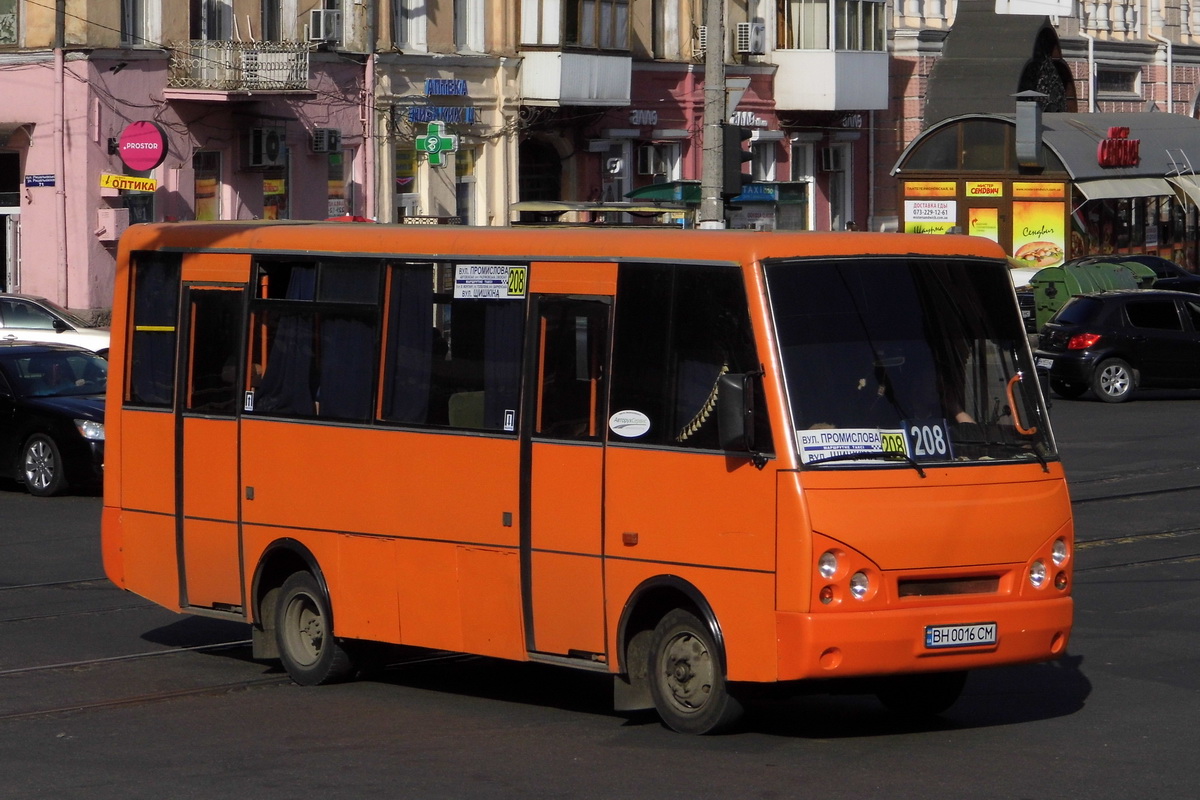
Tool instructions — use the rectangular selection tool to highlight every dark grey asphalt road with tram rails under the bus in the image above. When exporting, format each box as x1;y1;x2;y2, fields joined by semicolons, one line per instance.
0;393;1200;799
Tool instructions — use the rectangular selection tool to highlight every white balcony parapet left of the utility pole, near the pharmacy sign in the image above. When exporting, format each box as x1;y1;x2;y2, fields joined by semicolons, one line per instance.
521;50;634;106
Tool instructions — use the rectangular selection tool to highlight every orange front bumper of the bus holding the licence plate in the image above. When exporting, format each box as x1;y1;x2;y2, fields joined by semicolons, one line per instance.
778;596;1074;680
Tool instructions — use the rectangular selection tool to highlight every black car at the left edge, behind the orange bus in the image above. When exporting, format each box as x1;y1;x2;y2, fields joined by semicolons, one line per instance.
0;343;108;497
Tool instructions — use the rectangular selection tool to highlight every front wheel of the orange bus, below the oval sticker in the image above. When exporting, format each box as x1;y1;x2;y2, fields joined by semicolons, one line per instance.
649;608;742;734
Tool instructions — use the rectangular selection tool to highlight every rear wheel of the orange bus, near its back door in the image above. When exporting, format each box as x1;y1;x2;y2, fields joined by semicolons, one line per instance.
275;572;354;686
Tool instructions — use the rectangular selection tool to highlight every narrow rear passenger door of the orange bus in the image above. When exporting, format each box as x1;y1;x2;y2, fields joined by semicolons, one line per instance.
175;285;246;612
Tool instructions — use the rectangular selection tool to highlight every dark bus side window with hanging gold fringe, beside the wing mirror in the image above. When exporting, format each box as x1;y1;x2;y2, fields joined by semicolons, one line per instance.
611;264;770;450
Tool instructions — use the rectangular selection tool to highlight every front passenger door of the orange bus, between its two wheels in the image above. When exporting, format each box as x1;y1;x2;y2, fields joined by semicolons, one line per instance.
521;291;616;662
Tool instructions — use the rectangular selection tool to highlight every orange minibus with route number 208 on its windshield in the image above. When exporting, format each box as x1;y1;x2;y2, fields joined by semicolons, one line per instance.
103;222;1073;733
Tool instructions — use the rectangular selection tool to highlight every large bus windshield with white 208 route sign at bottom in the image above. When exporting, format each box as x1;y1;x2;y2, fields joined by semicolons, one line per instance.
766;257;1055;471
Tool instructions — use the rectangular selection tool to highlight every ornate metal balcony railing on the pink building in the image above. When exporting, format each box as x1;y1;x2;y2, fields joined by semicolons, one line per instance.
167;40;311;91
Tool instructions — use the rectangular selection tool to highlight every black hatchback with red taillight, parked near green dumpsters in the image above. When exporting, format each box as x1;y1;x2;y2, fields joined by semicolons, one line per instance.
1036;289;1200;403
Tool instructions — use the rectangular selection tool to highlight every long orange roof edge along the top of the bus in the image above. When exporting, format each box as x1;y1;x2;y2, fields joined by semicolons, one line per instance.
121;221;1006;263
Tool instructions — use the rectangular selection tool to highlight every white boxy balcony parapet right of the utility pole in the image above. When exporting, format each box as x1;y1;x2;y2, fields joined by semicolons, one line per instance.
769;50;888;112
